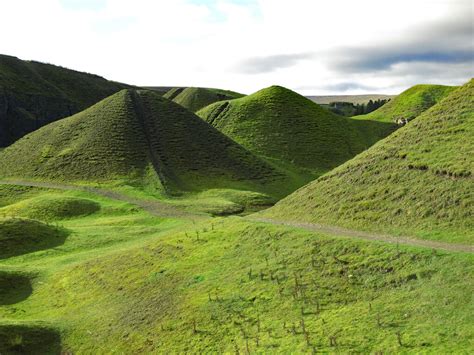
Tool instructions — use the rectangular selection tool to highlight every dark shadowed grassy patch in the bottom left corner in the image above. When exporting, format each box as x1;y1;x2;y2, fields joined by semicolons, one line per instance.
0;323;61;355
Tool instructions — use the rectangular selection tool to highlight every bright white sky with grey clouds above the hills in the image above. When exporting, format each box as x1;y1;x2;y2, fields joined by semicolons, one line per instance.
0;0;474;95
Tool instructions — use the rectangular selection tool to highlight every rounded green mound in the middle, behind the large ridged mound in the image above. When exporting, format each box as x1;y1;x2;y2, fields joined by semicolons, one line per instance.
198;86;393;175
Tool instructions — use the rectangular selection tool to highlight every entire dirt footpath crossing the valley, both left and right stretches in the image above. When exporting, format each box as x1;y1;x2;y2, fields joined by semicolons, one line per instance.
0;180;474;253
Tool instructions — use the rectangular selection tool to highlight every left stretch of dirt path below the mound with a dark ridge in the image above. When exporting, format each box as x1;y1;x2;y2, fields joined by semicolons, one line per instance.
0;180;205;219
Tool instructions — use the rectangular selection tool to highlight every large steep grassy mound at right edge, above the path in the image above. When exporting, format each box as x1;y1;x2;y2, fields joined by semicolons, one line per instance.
263;80;474;243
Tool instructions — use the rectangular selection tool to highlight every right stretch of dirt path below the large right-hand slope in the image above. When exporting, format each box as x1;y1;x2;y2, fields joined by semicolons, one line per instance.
247;217;474;253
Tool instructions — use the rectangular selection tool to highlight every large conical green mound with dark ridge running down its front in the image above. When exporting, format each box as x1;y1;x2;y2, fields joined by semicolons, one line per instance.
0;90;290;195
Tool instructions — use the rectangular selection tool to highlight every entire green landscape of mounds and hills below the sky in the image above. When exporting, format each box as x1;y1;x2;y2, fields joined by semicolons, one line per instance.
0;55;474;354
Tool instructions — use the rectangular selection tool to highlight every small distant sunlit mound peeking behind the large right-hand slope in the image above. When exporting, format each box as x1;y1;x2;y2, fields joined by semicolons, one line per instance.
354;84;457;122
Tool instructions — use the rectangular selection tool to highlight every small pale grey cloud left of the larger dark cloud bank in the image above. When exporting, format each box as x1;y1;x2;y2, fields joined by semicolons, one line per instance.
235;53;314;74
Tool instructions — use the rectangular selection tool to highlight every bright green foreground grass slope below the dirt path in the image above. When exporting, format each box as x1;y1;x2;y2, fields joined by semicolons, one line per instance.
0;189;474;353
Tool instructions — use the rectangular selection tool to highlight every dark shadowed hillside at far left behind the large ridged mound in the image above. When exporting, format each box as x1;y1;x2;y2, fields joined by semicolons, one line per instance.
0;55;128;147
